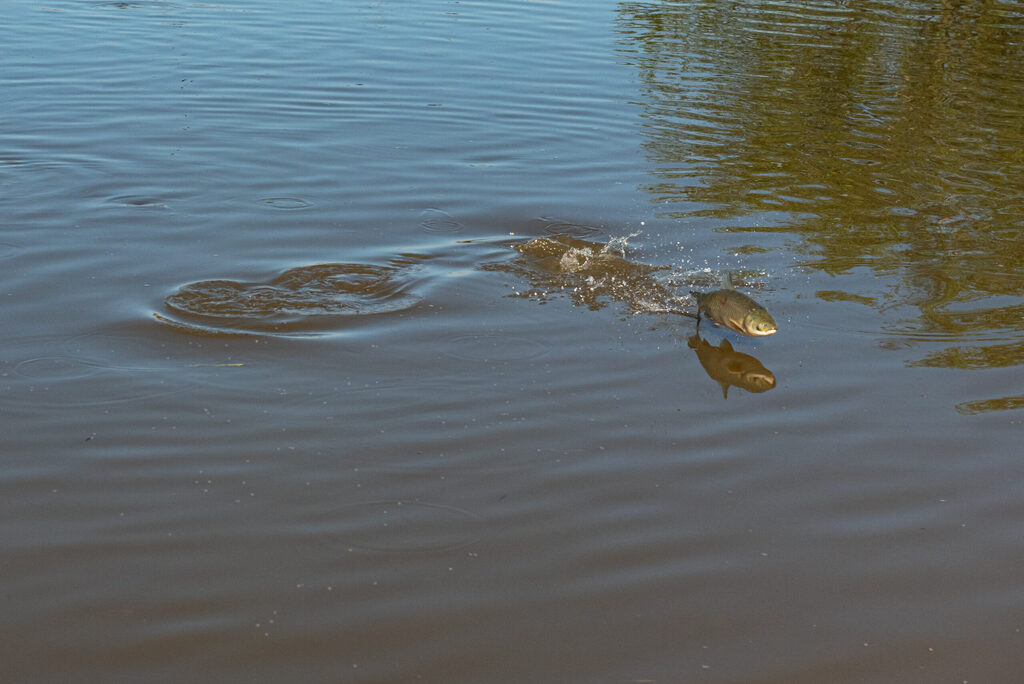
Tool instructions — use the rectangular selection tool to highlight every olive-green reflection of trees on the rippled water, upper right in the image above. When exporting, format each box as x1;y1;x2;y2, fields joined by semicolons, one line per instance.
617;1;1024;405
